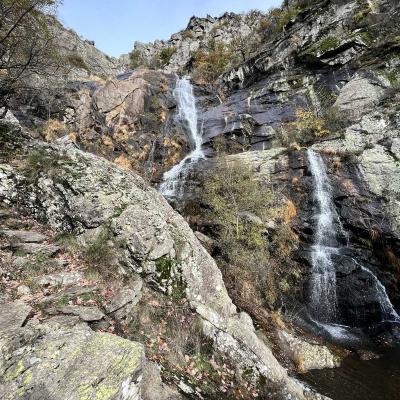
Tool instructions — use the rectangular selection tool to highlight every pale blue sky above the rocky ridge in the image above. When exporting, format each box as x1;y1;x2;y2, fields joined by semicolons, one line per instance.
59;0;281;56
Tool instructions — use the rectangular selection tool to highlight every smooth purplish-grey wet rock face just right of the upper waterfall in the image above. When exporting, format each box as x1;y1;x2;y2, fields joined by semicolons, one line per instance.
199;75;300;153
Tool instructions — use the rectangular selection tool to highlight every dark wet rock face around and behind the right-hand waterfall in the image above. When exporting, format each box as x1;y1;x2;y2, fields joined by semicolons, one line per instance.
228;139;400;328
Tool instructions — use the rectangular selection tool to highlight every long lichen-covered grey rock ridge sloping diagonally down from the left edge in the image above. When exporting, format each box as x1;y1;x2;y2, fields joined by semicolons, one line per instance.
0;125;324;399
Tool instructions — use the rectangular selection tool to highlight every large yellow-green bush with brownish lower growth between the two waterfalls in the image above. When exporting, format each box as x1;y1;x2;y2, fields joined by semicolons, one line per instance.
202;161;298;313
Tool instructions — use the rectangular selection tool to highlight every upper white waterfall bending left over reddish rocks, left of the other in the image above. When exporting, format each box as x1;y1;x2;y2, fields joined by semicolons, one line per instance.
159;77;205;197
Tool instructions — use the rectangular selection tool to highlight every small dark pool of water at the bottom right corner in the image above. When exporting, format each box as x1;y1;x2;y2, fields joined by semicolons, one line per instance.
302;346;400;400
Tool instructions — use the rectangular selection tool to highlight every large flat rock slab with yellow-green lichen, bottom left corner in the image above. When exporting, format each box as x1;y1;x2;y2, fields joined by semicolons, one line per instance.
0;303;145;400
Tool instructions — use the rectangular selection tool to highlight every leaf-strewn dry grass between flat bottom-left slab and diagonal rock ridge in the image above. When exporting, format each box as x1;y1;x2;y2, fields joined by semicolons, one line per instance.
125;291;256;400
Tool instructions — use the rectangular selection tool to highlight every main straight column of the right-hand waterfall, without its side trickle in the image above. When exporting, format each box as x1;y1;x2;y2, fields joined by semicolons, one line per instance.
308;150;337;322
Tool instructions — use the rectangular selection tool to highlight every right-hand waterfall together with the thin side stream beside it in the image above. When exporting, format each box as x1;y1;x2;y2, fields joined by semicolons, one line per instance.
307;149;400;328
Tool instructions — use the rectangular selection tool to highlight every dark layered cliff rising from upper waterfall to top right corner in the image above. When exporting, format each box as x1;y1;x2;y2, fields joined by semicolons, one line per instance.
198;1;400;157
